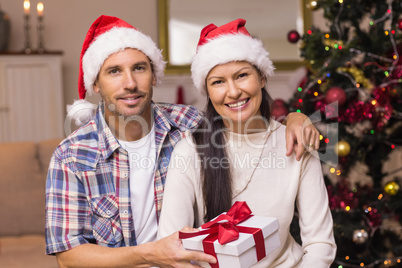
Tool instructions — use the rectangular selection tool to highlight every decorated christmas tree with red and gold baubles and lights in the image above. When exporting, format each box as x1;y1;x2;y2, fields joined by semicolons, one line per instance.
280;0;402;267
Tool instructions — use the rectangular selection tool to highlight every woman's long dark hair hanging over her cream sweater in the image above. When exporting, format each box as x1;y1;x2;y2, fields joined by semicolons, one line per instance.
193;88;272;222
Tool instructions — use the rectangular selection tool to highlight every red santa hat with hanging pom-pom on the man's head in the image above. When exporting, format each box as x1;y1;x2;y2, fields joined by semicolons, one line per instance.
67;15;166;125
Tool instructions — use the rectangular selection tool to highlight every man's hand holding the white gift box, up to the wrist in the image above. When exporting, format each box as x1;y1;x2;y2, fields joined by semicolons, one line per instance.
147;227;216;268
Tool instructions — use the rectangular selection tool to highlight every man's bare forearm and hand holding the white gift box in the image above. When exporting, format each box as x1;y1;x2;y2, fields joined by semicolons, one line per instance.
56;227;216;268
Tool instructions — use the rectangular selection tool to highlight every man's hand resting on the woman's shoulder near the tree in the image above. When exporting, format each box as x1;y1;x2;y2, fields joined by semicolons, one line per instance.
284;113;320;161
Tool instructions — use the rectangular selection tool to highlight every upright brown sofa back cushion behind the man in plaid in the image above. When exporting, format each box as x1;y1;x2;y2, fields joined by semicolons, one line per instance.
0;142;45;236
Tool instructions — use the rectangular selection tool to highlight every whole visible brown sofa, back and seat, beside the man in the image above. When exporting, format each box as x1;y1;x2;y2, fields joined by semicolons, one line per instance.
0;139;61;268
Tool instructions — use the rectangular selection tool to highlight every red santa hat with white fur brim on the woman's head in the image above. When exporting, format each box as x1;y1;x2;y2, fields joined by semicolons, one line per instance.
191;19;275;93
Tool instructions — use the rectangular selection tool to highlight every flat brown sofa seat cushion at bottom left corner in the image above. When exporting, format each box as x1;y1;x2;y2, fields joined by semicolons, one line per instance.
0;235;58;268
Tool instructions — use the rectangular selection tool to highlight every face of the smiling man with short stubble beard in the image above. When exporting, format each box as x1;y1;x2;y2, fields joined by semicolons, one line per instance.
94;48;156;122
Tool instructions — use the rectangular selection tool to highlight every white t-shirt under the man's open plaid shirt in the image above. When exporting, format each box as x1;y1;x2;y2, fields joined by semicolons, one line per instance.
119;124;158;245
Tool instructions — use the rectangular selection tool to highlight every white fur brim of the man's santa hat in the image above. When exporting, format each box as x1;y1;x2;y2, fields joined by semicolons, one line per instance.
82;27;166;94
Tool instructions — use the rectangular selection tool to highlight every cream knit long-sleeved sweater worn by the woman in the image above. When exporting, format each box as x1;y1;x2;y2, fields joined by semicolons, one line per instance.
158;120;336;268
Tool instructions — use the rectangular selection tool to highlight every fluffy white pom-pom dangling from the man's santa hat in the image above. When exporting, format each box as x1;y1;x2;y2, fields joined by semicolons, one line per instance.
67;100;96;126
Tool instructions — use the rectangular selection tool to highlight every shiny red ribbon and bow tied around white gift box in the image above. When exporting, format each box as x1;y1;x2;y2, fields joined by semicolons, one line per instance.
179;201;266;268
